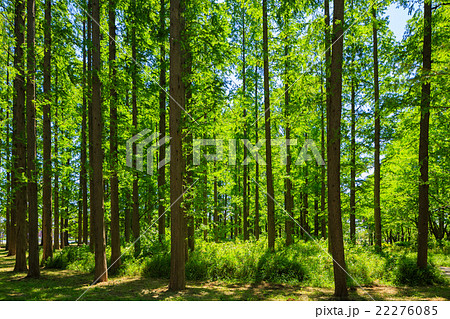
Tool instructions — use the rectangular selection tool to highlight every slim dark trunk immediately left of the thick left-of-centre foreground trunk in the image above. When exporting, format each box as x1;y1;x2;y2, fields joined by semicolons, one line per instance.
158;0;166;241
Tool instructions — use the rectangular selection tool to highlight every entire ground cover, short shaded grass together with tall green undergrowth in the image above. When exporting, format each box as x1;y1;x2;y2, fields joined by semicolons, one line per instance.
0;240;450;300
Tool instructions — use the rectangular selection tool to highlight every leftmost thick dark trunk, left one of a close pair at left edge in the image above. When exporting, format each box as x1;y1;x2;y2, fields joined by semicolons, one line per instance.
13;0;27;272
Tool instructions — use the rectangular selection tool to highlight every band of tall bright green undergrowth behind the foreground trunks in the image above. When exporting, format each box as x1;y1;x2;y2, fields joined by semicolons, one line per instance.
42;240;450;288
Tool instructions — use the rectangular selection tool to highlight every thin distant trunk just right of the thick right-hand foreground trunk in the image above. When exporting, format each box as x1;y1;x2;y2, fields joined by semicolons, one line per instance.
350;78;356;244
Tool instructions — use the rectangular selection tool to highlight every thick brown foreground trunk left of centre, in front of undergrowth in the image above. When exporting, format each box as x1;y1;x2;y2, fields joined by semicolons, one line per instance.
169;0;186;291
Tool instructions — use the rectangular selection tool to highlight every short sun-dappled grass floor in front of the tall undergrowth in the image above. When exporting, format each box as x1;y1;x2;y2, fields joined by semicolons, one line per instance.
0;249;450;301
